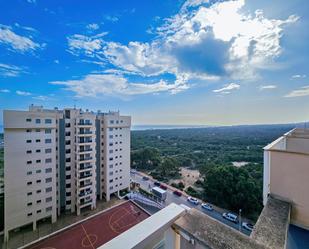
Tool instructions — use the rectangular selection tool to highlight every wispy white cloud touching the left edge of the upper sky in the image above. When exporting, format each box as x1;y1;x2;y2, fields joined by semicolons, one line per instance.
0;24;45;53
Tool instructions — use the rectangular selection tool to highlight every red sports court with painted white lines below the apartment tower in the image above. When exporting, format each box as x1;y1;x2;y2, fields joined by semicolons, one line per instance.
27;201;149;249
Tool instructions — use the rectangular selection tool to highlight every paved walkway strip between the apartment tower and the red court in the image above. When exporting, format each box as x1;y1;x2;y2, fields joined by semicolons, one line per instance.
0;197;124;249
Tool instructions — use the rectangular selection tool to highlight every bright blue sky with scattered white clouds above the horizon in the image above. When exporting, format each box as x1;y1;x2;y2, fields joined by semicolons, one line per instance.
0;0;309;125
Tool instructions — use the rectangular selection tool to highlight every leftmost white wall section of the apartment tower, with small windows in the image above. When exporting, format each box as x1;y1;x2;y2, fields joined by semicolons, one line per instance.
4;111;57;239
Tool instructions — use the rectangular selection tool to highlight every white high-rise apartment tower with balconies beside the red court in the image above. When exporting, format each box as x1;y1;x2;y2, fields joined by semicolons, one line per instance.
3;106;131;239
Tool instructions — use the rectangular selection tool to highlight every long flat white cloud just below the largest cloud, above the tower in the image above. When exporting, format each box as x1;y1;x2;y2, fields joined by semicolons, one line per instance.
50;74;188;97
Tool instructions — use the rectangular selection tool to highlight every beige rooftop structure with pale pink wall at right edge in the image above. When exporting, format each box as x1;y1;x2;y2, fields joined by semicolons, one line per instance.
263;129;309;229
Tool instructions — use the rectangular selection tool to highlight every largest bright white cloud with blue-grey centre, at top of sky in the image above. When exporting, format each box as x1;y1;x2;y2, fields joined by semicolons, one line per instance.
63;0;298;97
